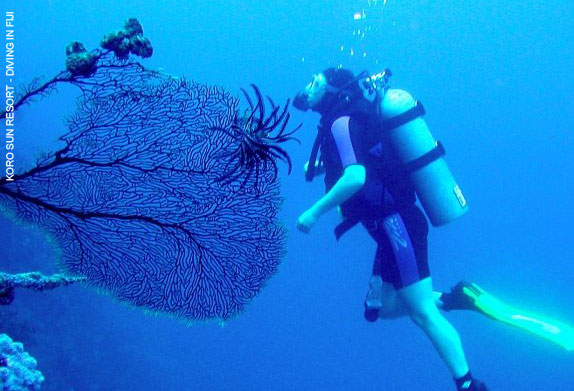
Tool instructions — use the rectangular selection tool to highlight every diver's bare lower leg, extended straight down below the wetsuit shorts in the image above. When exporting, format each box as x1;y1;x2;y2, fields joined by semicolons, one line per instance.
398;277;468;378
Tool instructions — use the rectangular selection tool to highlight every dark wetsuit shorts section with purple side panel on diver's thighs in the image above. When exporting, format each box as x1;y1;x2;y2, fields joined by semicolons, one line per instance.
363;204;430;289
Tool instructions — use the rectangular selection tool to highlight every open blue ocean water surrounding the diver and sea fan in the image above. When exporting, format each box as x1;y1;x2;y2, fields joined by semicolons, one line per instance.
0;0;574;391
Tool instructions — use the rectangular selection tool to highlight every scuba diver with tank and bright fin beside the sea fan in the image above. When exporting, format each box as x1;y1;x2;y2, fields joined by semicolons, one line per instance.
293;68;574;391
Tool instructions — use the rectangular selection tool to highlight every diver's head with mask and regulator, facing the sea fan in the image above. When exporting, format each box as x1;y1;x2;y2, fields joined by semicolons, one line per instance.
293;68;362;114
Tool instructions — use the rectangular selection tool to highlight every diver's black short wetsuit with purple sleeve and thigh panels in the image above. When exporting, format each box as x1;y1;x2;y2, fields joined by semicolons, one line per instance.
320;102;430;289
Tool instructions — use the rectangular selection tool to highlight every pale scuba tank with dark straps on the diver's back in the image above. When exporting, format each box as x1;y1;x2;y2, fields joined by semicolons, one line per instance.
363;70;468;226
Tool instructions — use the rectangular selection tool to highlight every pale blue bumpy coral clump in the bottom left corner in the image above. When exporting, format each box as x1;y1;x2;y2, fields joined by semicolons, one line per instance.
0;334;44;391
